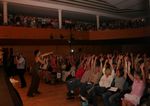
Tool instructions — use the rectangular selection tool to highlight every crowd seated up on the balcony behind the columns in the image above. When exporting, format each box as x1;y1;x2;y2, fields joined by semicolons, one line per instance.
0;13;146;31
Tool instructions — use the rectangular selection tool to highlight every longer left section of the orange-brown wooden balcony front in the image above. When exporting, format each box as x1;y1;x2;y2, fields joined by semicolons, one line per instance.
0;26;88;39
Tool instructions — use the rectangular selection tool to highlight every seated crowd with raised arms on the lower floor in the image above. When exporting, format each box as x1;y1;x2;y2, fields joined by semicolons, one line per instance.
2;47;150;106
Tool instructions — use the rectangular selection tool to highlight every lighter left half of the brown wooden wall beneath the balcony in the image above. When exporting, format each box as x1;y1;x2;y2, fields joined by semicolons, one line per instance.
1;45;69;64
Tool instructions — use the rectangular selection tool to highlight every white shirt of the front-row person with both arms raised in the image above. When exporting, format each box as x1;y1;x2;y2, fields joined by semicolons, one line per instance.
99;68;115;88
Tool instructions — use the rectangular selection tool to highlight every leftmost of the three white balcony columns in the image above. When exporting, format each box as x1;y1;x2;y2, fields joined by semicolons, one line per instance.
3;1;8;24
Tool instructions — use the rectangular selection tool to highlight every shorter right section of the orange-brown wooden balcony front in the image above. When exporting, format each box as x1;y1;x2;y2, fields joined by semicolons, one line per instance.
89;27;150;40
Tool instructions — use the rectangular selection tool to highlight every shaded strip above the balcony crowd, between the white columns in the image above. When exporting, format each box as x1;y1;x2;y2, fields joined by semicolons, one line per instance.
8;3;96;22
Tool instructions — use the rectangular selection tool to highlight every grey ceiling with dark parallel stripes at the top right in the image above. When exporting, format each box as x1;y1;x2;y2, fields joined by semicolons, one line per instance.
32;0;149;17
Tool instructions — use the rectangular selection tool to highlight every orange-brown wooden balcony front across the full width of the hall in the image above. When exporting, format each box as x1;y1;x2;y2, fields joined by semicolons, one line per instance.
0;26;150;40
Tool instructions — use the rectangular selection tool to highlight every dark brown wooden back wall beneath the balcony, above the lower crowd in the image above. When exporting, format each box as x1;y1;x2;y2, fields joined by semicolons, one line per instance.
2;44;150;65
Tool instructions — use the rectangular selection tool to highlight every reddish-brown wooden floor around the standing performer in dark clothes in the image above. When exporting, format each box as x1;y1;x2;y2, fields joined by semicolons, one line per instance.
14;75;80;106
